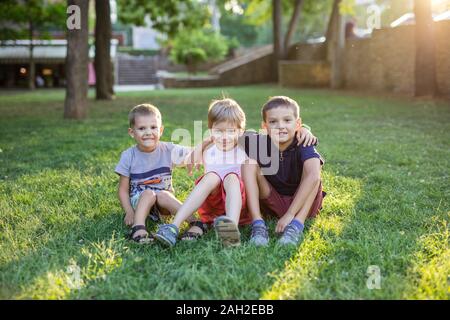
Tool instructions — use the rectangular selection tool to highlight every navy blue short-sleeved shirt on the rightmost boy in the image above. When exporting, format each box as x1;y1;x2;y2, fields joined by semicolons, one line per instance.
240;131;324;196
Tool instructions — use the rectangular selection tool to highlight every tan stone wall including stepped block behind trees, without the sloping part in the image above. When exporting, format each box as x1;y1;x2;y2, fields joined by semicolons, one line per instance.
279;20;450;96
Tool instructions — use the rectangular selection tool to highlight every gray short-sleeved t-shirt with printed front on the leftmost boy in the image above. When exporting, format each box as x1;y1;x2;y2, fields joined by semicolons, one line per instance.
115;142;191;197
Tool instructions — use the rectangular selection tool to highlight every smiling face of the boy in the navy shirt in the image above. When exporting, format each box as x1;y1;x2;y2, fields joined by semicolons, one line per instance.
262;106;301;150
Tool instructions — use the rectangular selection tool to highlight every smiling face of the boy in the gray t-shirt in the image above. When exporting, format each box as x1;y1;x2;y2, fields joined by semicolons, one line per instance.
128;114;164;152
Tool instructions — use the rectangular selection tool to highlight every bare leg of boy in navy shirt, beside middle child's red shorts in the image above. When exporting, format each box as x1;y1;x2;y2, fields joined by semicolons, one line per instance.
241;160;270;221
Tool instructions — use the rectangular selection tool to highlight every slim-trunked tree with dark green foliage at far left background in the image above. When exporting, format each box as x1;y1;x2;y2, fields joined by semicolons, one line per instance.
0;0;65;90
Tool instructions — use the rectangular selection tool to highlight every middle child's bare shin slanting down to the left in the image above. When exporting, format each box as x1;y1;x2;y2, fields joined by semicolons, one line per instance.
172;173;220;228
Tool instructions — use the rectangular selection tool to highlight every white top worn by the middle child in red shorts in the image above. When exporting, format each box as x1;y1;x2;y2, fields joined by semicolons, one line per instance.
203;144;247;180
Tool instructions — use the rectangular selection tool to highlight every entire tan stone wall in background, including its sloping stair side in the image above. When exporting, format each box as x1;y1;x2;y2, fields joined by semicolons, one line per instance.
164;20;450;97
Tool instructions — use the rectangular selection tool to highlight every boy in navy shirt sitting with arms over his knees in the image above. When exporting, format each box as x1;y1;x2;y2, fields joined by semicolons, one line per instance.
242;96;325;245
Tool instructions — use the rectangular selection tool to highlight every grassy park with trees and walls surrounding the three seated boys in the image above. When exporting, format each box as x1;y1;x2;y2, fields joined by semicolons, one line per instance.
0;0;450;299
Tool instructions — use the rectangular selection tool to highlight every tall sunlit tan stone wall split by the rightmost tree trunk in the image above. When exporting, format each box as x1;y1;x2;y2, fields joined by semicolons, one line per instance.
345;21;450;96
